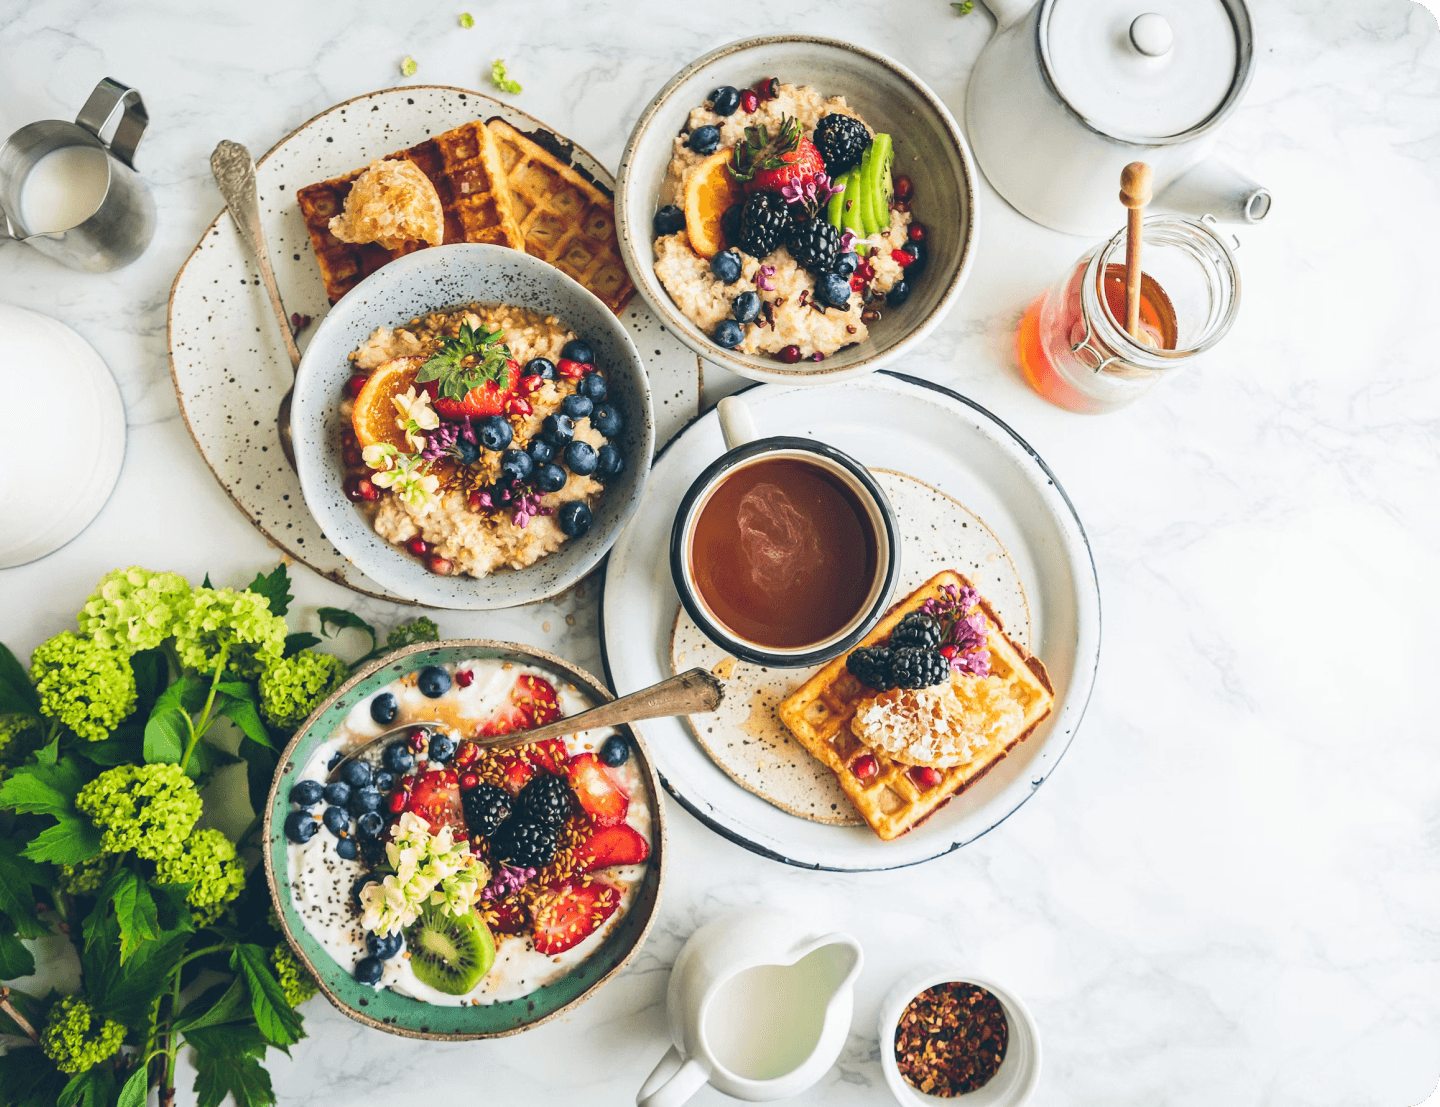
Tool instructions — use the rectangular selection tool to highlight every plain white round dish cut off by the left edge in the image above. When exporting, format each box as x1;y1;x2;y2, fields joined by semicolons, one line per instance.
0;304;125;569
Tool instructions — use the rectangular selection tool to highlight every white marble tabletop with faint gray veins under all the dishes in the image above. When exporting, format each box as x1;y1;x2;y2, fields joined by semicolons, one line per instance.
0;0;1440;1107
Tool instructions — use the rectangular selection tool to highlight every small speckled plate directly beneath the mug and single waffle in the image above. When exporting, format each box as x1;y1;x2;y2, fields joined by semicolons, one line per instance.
670;469;1030;826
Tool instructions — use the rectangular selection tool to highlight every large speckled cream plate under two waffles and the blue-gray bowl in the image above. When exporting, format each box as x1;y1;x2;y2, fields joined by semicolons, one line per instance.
168;85;700;603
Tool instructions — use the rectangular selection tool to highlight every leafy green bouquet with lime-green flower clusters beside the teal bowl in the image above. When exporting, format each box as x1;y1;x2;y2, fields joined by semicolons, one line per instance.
0;564;439;1107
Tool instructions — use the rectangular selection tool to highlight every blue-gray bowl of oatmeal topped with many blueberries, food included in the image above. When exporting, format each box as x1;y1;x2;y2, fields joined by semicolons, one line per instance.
291;243;655;609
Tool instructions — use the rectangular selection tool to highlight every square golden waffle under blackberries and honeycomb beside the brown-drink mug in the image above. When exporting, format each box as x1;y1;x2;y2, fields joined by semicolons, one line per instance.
779;570;1054;841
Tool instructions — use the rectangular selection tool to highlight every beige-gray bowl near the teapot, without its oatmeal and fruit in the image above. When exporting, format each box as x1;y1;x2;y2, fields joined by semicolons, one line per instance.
615;35;978;384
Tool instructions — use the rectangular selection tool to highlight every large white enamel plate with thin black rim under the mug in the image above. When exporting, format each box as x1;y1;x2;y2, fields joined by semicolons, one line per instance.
600;371;1100;872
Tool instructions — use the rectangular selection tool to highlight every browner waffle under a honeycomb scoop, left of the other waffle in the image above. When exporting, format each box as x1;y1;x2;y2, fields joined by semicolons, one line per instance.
295;122;524;304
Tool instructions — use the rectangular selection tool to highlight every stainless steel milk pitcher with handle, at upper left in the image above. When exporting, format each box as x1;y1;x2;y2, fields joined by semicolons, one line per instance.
0;78;156;274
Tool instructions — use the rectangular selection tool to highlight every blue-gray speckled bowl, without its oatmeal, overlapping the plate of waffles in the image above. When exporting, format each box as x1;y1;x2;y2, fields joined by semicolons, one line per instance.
291;243;655;610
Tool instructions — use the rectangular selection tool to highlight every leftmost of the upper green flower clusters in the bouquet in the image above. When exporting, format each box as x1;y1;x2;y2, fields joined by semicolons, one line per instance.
30;631;135;741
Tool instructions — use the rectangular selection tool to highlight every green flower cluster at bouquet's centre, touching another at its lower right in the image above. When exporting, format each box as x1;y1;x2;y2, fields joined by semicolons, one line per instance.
75;764;200;861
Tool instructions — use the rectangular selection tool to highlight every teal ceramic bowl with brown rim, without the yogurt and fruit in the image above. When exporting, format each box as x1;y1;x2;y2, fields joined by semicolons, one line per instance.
265;638;665;1041
